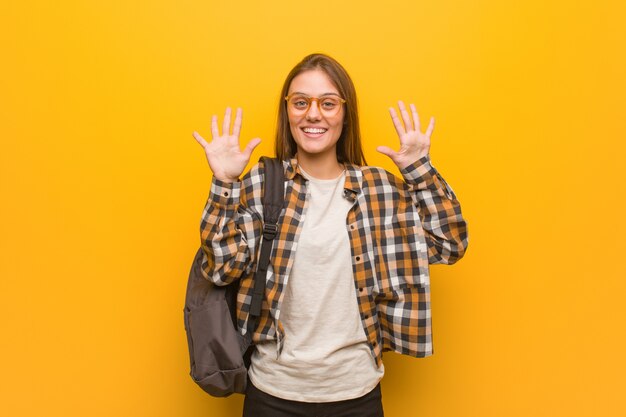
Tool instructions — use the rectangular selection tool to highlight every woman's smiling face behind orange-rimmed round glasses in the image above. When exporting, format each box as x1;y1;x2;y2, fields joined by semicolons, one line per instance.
288;70;345;157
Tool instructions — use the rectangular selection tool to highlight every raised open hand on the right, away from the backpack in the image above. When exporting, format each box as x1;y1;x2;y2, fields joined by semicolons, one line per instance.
376;101;435;169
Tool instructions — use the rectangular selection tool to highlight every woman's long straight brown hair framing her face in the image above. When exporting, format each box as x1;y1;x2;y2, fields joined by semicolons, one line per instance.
274;54;367;166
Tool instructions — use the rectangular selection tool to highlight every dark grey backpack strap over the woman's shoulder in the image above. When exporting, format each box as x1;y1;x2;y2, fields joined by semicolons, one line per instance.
248;156;285;332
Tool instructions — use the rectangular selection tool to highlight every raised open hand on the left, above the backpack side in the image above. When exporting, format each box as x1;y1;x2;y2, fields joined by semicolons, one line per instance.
193;107;261;182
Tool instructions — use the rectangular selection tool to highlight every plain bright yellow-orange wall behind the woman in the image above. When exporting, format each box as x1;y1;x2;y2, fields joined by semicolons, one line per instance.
0;0;626;417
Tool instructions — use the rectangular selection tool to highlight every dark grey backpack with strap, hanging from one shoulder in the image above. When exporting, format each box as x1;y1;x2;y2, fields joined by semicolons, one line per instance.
183;157;285;397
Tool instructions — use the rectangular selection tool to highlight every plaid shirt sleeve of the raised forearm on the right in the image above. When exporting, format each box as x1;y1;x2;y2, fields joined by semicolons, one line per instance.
400;156;468;264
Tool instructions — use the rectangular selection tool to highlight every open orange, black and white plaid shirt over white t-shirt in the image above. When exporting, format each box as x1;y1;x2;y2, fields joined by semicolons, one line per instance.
200;156;468;366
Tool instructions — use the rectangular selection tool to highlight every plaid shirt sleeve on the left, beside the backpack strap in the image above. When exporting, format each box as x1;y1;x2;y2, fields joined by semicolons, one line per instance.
200;168;262;285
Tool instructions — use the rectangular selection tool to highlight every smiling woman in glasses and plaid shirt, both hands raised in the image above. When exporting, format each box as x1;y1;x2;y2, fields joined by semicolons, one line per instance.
194;54;467;417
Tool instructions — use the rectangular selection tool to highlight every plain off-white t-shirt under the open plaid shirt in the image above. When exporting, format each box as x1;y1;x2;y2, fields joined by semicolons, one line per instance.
249;167;384;402
